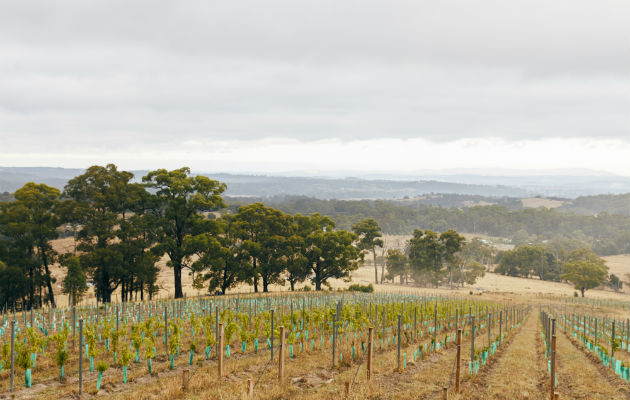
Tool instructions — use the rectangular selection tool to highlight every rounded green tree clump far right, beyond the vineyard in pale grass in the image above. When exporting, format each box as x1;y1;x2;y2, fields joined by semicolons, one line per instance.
495;243;622;297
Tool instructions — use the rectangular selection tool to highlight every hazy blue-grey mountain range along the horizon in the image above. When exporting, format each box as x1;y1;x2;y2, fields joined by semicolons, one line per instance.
0;167;630;199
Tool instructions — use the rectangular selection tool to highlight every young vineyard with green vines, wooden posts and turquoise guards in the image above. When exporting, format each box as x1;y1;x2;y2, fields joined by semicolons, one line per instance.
0;292;630;399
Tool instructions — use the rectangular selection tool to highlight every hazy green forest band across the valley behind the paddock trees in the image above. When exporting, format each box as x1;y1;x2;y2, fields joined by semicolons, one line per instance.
227;195;630;255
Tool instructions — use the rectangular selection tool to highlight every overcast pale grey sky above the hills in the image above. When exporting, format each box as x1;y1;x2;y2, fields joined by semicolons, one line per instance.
0;0;630;175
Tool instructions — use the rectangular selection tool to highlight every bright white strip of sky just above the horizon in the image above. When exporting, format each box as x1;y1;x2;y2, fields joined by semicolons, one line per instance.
0;138;630;176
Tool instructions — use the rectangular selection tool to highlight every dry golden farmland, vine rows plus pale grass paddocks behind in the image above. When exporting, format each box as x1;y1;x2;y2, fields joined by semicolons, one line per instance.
11;236;630;399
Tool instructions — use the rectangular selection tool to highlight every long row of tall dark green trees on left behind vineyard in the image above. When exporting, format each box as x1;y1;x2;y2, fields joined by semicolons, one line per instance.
0;164;370;307
